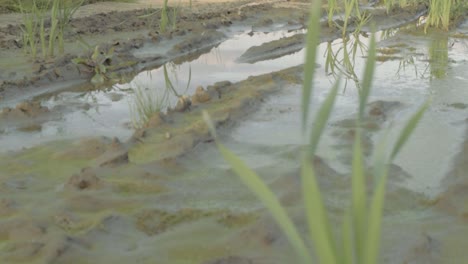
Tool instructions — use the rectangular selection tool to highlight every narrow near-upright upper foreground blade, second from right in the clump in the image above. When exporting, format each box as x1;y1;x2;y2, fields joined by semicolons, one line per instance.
359;30;376;120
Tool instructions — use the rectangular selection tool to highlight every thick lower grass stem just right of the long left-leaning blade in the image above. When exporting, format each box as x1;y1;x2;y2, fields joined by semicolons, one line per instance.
301;155;337;264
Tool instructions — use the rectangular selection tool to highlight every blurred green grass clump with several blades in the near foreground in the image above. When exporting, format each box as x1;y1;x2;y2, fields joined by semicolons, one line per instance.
204;1;427;264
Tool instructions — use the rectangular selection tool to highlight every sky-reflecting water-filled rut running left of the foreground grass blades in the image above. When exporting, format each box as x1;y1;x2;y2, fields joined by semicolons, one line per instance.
0;25;304;151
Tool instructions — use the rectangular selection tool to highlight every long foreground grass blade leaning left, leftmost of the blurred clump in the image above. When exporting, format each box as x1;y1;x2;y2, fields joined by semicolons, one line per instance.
216;142;312;264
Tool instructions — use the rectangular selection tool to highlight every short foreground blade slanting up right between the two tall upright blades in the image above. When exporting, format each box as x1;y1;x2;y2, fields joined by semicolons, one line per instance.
309;78;341;157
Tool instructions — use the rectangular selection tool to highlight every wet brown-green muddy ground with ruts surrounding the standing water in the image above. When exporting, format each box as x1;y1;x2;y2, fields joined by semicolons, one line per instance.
0;1;468;264
